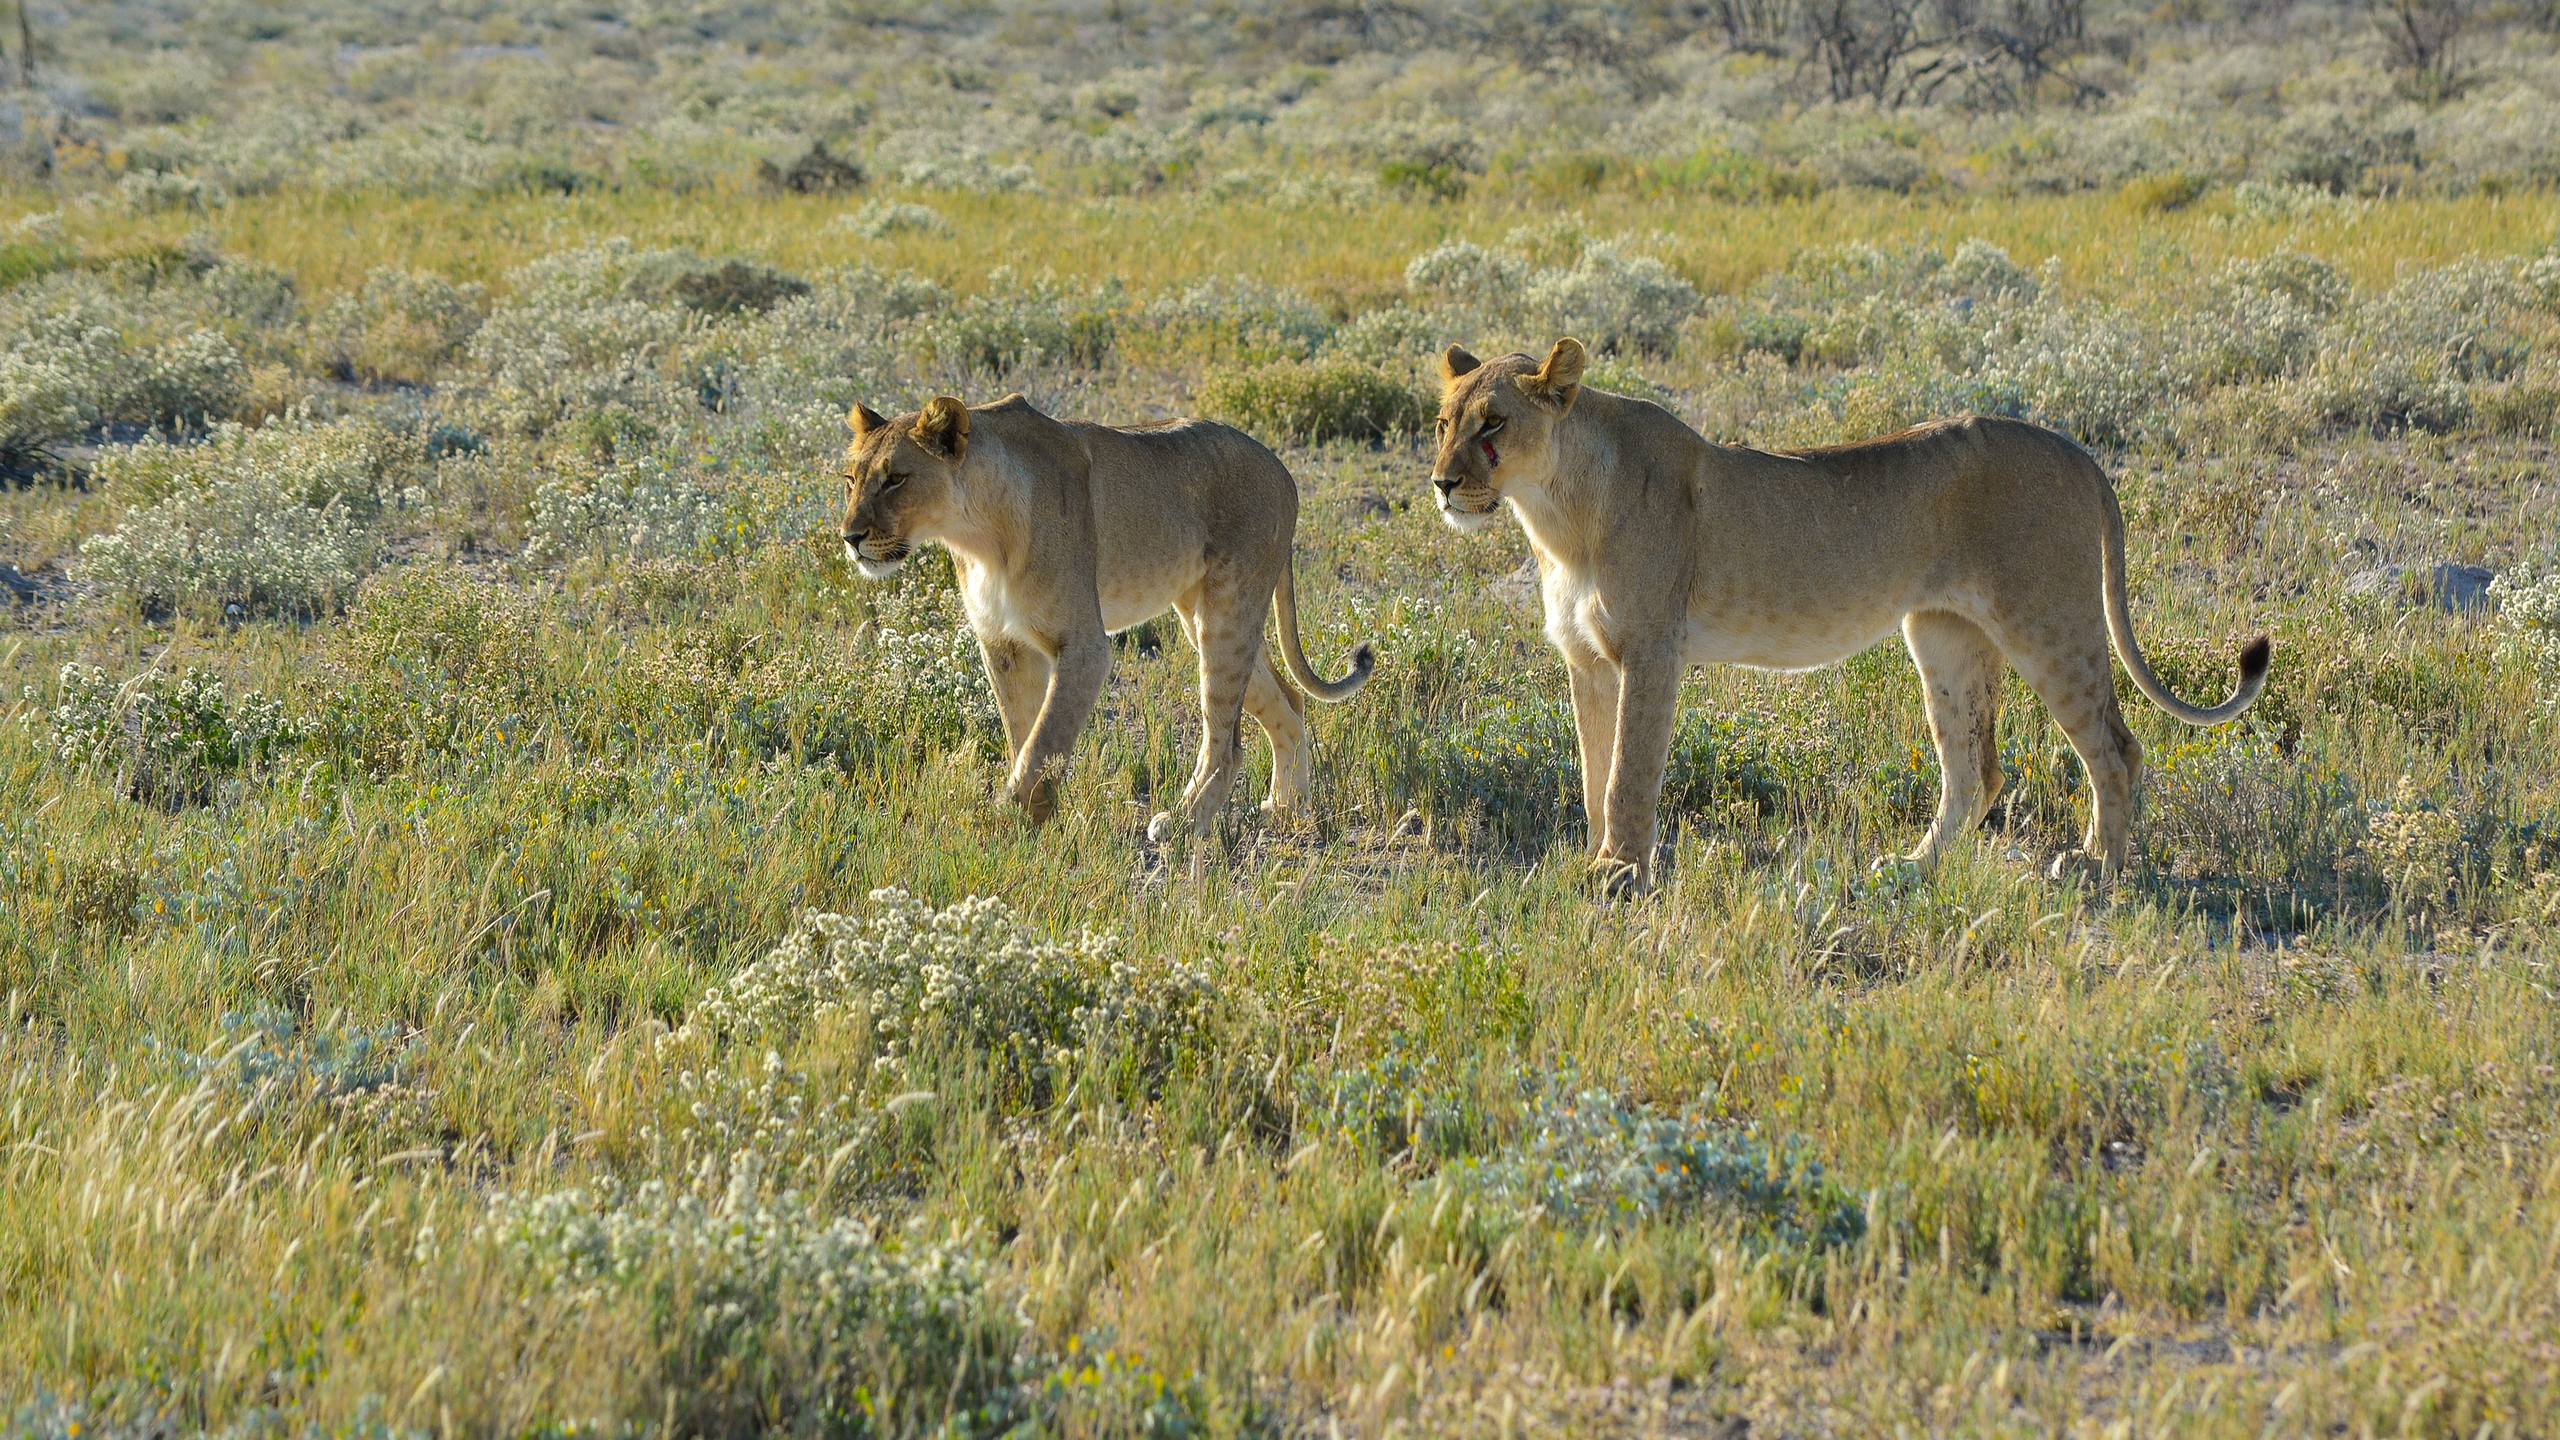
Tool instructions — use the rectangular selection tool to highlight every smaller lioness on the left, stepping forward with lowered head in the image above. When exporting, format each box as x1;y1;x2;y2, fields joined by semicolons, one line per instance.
842;395;1372;840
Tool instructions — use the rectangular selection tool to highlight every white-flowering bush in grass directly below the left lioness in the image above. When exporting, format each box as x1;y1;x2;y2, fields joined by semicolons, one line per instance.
676;889;1216;1104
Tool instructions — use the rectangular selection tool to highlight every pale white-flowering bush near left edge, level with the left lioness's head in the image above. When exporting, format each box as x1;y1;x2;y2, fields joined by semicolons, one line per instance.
74;415;417;618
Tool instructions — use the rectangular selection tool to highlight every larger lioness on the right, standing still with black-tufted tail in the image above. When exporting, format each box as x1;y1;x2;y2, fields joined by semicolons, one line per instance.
1431;338;2268;889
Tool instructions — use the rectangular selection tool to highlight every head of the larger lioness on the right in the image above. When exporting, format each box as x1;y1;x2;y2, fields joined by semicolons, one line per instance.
1431;338;1585;530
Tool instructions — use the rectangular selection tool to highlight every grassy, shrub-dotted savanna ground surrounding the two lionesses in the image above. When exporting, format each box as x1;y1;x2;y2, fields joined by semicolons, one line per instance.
0;0;2560;1440
